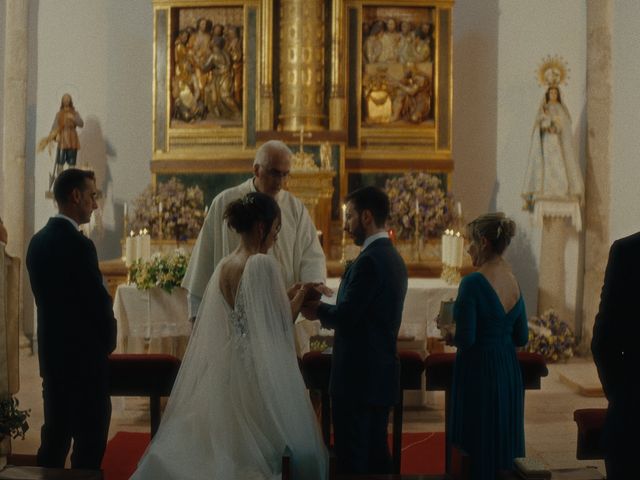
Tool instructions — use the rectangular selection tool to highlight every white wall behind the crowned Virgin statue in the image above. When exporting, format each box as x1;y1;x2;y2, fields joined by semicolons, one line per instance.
496;0;586;315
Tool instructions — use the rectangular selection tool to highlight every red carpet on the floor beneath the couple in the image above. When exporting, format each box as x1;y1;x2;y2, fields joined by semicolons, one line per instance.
102;432;444;480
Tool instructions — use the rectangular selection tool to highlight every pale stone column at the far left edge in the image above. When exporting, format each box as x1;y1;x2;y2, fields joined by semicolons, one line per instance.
2;0;27;258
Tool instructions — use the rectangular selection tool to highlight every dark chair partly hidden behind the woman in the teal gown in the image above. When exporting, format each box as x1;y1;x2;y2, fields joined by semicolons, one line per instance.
425;352;549;473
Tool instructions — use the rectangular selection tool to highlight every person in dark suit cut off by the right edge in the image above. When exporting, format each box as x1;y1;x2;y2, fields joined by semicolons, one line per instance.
591;233;640;480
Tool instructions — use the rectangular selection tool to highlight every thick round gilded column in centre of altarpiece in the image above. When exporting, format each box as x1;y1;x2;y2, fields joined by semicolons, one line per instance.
279;0;325;131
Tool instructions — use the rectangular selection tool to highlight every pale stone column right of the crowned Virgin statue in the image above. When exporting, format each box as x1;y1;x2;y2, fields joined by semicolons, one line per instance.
581;0;613;350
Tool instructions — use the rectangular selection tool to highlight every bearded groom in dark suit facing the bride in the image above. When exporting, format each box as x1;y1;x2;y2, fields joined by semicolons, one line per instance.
302;187;407;474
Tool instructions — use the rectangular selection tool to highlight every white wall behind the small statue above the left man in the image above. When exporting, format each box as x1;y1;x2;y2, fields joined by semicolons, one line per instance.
29;0;153;259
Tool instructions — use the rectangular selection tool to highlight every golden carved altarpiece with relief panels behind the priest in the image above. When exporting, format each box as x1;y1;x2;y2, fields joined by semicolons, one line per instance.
151;0;453;274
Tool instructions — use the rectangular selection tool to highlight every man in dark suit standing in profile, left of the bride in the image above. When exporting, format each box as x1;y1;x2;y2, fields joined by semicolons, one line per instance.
27;168;116;469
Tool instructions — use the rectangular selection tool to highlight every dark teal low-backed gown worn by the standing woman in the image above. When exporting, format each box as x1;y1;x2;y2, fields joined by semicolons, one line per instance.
450;272;528;480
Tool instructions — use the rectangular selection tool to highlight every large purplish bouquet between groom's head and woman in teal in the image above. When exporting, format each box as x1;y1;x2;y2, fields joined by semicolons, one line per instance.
385;172;455;240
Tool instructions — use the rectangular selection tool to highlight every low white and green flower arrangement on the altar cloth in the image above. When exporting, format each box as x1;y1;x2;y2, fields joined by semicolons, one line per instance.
130;250;189;293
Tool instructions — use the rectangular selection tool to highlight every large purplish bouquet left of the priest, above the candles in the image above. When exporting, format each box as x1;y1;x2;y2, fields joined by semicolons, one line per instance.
130;177;205;240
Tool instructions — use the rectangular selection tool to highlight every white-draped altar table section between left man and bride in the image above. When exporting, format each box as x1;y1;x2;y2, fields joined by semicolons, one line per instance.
113;285;191;358
